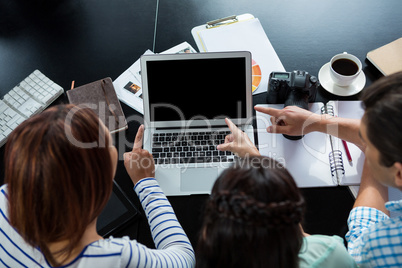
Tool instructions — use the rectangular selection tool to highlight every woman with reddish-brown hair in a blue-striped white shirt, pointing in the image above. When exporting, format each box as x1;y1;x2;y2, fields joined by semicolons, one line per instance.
0;105;194;267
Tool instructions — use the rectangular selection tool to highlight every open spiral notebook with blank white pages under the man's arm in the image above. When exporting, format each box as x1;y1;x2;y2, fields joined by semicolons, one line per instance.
256;101;364;188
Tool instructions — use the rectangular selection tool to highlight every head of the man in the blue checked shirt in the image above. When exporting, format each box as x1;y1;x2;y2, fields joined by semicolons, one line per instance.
360;72;402;189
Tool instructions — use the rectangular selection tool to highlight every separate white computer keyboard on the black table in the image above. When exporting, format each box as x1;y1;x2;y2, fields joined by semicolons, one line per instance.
0;70;64;147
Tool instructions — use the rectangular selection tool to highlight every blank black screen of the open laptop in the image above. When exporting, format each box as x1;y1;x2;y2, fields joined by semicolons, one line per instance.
146;57;247;121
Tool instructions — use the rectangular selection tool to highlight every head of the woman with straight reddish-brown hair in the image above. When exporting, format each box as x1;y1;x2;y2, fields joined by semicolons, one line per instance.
5;105;117;263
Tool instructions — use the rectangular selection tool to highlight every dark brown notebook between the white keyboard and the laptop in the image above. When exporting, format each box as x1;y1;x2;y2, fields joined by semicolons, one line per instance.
67;77;128;133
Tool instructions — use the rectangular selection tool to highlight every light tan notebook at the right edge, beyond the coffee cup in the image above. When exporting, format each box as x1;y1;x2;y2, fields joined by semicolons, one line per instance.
367;38;402;75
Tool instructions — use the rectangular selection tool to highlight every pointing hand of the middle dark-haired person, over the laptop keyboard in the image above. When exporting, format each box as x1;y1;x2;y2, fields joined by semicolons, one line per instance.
217;118;260;158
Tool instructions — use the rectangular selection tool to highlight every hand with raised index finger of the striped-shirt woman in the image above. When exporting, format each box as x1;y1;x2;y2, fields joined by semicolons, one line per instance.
123;125;155;185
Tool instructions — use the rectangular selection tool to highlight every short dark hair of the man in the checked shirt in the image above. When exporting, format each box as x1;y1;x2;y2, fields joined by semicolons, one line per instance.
361;72;402;167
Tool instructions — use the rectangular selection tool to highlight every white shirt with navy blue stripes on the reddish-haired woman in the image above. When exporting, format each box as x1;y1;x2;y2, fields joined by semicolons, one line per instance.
0;178;195;267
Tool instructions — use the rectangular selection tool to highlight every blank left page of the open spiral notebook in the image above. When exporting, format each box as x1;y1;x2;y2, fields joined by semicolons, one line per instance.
256;103;337;188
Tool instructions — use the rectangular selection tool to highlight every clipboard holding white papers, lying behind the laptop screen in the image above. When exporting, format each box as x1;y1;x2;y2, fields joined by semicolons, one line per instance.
191;13;285;94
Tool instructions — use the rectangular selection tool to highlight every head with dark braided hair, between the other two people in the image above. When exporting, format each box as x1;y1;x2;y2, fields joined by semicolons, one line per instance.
196;156;305;267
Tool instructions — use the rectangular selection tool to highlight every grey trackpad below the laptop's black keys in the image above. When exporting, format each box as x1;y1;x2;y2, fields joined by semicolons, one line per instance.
180;168;218;192
